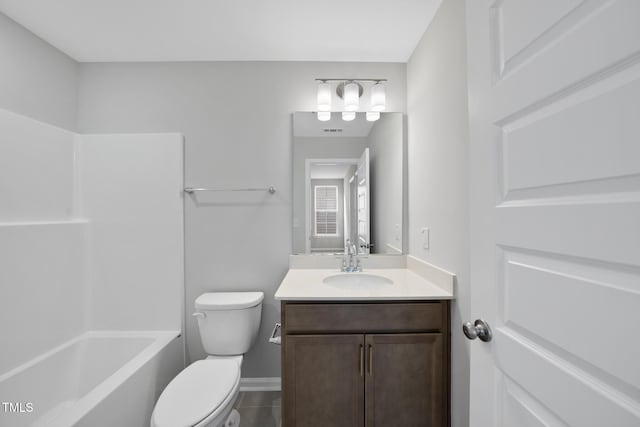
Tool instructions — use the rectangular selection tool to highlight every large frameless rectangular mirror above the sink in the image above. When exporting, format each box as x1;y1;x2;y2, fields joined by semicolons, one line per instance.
292;112;405;255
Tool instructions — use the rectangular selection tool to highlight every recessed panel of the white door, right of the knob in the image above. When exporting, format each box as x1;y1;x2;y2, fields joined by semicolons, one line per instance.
499;247;640;389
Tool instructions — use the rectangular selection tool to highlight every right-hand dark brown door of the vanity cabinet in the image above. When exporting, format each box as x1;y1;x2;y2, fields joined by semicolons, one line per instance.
365;333;448;427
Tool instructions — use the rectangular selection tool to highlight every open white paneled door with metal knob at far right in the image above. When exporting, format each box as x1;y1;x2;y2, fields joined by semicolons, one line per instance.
467;0;640;427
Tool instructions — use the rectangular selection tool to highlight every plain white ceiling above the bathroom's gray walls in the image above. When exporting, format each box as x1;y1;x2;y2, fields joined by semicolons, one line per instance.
0;0;441;62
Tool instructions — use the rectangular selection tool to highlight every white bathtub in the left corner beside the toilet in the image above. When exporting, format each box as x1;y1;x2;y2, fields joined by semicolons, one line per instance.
0;331;184;427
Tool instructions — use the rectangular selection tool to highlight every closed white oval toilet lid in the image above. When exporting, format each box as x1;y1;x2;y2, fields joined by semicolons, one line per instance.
153;359;240;427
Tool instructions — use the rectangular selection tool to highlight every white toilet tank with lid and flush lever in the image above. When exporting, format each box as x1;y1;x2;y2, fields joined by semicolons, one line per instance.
194;292;264;356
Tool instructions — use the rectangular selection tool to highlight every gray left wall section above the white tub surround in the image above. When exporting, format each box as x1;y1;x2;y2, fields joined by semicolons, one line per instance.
0;13;78;130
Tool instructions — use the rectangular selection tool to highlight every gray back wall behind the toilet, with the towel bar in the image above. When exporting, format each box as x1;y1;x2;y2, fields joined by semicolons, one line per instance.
78;62;406;377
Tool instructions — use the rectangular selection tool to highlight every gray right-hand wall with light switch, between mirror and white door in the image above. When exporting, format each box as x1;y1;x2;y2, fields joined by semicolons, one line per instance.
407;0;469;427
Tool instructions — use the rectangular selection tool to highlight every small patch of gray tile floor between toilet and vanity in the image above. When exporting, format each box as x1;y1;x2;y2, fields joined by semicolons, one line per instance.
233;391;280;427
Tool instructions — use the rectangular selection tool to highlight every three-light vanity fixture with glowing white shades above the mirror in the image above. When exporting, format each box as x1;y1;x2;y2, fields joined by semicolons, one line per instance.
316;79;387;121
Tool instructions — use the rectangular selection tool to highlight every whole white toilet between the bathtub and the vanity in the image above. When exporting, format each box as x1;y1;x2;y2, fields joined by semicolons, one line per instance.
151;292;264;427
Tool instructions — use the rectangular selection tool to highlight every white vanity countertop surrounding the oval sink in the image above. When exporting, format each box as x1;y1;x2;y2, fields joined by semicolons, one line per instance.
275;268;453;301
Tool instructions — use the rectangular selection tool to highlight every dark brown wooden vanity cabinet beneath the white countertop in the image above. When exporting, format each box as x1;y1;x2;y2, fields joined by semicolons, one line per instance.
282;300;450;427
